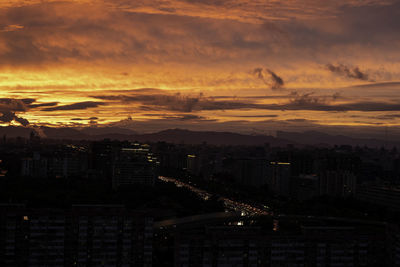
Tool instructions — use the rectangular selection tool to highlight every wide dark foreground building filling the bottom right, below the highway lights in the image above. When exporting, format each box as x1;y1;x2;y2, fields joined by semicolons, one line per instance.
166;217;399;267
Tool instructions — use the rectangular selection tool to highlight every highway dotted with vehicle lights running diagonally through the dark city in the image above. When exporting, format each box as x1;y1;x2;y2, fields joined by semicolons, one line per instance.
158;176;271;216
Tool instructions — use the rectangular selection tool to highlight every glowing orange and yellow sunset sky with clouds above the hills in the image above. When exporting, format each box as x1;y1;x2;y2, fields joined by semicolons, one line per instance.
0;0;400;134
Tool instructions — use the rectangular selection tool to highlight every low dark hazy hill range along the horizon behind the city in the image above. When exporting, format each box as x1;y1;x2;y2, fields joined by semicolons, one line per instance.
0;126;400;147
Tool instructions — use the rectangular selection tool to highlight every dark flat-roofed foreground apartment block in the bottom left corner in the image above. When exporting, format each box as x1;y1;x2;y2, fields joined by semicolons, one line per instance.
0;205;153;267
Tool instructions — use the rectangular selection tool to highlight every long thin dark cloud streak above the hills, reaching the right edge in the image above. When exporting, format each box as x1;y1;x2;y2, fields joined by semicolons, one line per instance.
93;92;400;112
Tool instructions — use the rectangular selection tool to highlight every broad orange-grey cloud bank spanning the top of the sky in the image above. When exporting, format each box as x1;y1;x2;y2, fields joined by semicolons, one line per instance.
0;0;400;74
